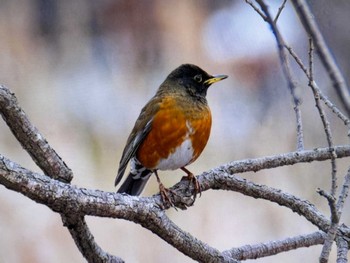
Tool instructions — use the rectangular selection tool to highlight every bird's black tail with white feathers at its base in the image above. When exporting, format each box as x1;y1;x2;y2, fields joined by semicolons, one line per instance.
118;170;152;195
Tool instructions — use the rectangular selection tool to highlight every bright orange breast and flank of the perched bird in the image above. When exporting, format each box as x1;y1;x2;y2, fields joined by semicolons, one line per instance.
136;98;211;169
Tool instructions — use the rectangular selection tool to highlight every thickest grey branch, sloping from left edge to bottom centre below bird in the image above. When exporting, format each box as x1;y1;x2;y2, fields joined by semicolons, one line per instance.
0;155;235;262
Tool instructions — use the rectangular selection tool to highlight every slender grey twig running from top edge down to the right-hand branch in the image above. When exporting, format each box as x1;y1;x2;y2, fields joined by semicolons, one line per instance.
256;0;304;151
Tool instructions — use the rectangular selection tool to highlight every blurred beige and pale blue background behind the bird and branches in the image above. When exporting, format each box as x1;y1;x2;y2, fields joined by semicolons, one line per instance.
0;0;350;262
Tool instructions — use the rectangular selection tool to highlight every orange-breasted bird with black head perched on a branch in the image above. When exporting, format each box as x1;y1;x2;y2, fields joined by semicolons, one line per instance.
115;64;228;204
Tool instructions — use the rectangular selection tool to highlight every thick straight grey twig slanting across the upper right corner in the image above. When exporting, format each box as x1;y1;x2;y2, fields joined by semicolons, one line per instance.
291;0;350;116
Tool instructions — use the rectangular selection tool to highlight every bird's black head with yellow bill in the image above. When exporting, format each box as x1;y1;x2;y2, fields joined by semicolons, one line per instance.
166;64;227;97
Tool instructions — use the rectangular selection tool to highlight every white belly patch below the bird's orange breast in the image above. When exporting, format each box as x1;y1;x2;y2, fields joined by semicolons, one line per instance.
157;137;193;170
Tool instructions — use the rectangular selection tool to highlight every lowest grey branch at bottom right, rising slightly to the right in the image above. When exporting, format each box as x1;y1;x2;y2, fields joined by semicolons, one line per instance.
222;231;325;260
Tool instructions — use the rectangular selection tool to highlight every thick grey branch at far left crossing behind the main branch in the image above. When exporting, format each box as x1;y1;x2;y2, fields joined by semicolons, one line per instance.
0;85;115;262
